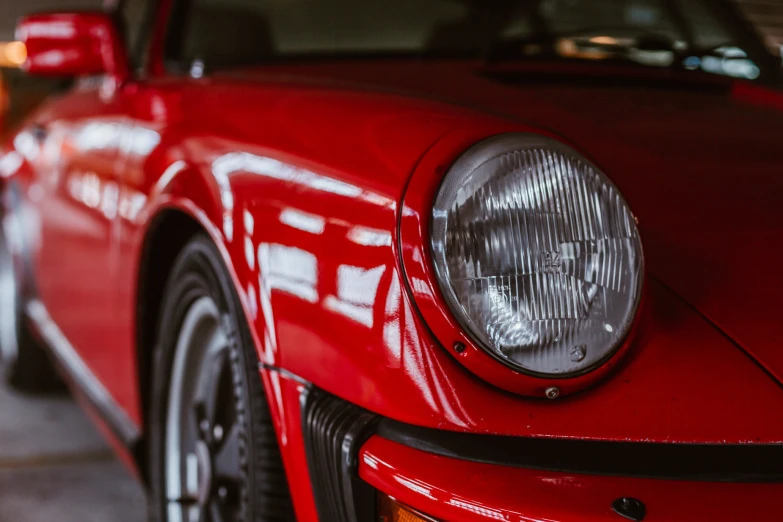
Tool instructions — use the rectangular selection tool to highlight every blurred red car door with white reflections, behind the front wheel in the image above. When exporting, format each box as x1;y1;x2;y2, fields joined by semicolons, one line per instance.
34;85;133;410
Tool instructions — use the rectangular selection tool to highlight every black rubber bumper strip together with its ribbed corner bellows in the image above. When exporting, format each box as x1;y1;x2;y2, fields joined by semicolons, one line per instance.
284;370;783;522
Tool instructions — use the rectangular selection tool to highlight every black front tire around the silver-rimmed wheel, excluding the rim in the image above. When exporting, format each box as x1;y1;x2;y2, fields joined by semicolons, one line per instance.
149;235;296;522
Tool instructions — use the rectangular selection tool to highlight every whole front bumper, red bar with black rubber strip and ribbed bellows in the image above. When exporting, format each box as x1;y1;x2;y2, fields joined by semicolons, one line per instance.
300;386;783;522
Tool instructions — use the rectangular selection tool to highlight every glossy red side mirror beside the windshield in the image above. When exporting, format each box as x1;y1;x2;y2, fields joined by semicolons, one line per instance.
16;11;130;82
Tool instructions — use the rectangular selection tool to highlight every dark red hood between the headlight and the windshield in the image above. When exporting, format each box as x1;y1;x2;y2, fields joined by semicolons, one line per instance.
258;63;783;382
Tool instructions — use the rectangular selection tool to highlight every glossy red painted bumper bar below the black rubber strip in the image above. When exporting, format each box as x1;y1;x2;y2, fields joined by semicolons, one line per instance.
359;436;783;522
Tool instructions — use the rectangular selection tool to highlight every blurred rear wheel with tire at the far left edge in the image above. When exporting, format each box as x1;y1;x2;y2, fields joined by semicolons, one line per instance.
0;201;63;393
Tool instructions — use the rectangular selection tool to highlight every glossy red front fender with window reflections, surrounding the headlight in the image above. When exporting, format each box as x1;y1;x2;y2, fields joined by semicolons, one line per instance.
101;77;783;442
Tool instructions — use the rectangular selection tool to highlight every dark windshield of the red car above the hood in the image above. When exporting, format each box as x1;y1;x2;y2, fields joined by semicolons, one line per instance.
166;0;779;80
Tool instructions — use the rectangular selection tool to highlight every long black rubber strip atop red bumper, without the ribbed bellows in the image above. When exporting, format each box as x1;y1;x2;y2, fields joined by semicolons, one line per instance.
376;419;783;483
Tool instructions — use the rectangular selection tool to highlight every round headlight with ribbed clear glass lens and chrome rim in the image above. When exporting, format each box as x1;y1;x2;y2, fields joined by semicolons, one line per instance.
431;134;643;377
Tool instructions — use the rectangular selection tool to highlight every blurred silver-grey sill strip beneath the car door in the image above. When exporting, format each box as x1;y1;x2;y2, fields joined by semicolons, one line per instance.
25;299;141;449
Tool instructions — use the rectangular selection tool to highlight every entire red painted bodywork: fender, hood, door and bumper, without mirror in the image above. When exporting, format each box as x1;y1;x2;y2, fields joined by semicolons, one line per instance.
6;2;783;521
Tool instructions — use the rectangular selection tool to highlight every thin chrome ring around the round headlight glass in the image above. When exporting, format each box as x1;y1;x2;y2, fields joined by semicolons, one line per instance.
428;133;644;379
